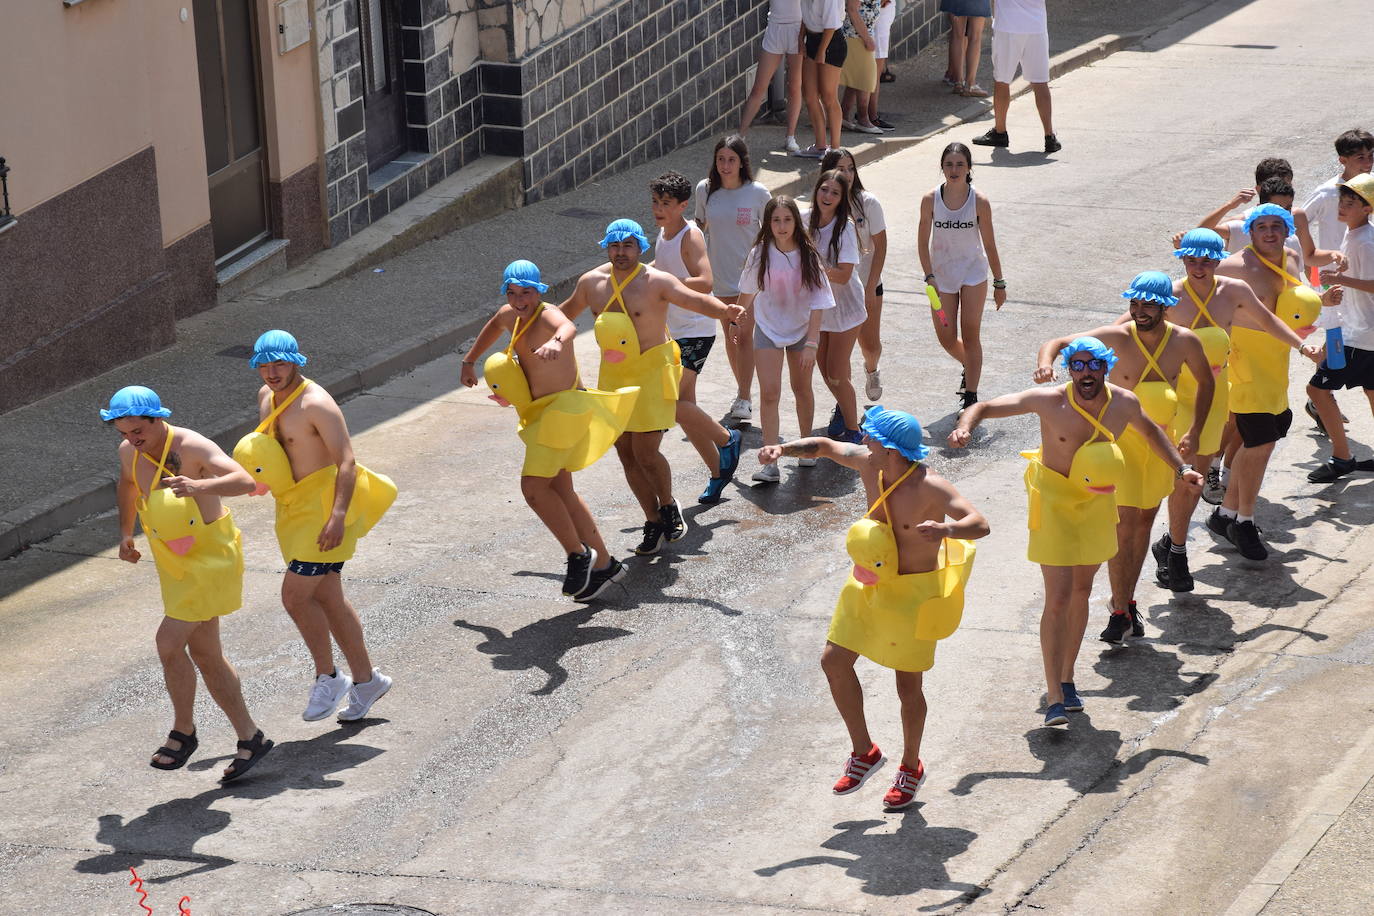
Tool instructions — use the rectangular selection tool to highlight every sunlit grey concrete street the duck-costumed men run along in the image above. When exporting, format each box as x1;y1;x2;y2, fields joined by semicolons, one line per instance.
0;0;1374;915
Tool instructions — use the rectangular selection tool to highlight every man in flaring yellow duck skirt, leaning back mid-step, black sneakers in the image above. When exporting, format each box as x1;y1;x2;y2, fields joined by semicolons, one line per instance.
462;261;639;602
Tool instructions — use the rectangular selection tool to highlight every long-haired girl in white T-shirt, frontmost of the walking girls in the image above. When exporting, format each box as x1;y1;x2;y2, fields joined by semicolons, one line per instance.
734;196;835;483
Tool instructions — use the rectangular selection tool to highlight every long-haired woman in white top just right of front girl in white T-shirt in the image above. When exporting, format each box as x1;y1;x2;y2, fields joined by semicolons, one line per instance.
804;169;868;442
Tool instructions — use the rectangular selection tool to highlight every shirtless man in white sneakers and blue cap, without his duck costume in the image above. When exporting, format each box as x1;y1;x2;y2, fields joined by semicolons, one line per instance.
249;331;392;722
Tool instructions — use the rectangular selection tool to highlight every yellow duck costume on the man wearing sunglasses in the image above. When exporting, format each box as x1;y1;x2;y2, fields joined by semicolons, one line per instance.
1021;379;1125;566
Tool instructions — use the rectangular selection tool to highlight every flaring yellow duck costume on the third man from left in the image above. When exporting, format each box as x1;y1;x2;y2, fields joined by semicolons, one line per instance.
482;302;639;477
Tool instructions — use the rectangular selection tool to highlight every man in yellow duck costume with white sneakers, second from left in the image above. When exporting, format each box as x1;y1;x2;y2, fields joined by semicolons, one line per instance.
234;330;396;722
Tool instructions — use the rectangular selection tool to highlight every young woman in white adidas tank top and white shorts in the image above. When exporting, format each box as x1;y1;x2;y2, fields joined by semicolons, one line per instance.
916;143;1007;411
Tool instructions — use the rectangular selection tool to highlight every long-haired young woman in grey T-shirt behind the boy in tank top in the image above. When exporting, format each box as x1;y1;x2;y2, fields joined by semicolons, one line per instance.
695;135;772;423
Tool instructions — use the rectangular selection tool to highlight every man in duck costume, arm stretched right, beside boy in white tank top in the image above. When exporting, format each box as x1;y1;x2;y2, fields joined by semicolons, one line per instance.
558;220;743;556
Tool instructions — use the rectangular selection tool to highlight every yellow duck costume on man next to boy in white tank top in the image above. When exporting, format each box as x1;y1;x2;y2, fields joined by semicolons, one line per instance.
592;258;683;433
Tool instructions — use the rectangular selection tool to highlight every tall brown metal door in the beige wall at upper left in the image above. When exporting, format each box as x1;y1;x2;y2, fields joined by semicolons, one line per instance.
194;0;268;266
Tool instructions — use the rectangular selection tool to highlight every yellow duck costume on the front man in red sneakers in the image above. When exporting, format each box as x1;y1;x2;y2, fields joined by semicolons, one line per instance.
826;408;976;672
